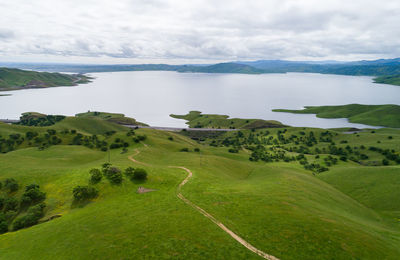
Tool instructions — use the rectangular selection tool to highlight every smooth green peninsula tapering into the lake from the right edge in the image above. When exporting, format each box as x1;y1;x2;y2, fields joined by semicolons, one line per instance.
273;104;400;128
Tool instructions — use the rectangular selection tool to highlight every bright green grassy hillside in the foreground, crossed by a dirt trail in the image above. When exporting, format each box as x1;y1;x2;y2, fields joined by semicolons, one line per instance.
0;116;400;259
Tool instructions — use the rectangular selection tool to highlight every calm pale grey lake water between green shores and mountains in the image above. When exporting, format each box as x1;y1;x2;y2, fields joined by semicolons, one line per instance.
0;71;400;128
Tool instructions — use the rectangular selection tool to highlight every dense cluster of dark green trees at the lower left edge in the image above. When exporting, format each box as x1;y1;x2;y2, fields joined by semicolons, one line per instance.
0;178;46;234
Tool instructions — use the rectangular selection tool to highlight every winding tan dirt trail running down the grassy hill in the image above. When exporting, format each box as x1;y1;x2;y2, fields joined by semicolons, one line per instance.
128;150;279;260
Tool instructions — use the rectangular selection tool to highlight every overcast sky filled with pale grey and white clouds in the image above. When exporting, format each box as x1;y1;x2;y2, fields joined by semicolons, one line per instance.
0;0;400;63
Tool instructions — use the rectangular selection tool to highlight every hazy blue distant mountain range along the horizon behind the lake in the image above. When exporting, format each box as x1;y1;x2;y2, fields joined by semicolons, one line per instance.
3;58;400;79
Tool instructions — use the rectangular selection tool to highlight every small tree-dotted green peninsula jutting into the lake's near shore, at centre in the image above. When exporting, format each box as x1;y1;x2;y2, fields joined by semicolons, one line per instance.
170;111;283;129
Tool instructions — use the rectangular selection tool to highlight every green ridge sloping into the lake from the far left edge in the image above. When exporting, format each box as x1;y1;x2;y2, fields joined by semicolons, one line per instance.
0;68;90;91
